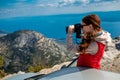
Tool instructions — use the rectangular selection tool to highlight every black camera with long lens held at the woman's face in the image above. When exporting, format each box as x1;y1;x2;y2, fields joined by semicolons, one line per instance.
66;23;83;38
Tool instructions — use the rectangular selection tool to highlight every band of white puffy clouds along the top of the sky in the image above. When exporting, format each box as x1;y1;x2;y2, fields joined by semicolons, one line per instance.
35;0;119;7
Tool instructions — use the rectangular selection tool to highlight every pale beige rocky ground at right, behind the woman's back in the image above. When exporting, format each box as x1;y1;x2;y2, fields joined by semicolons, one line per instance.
101;39;120;73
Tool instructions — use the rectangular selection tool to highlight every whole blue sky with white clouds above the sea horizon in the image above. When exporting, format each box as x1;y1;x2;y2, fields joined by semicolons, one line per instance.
0;0;120;18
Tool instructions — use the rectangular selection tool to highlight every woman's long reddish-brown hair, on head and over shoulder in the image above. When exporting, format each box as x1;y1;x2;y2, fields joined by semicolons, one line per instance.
78;14;101;53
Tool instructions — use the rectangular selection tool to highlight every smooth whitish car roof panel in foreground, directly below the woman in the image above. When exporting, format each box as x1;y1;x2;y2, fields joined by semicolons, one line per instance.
49;69;120;80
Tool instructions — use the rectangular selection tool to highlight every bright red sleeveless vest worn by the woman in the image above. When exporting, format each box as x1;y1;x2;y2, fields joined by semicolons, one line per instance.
77;42;105;69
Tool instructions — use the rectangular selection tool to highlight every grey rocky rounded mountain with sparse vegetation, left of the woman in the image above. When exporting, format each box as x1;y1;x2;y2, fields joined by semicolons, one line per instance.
0;30;70;73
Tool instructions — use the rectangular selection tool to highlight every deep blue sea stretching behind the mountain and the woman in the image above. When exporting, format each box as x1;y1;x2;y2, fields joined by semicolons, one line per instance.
0;11;120;39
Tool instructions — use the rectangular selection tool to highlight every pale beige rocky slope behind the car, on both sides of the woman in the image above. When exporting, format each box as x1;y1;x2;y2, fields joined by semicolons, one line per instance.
0;34;120;79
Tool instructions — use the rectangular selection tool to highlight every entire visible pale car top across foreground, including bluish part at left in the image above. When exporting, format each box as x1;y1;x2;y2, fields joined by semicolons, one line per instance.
6;67;120;80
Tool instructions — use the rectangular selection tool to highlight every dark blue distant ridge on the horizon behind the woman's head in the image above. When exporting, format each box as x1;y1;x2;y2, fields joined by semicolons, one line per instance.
46;11;120;22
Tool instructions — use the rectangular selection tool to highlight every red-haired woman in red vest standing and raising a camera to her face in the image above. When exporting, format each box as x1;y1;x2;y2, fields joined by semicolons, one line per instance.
67;14;111;69
